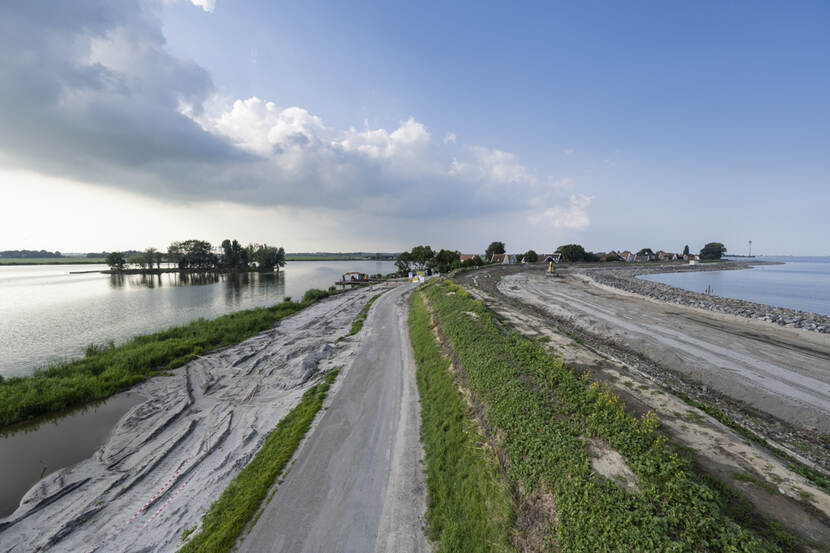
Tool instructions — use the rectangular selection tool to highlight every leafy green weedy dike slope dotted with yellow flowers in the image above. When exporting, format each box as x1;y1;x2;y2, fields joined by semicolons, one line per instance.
412;281;792;552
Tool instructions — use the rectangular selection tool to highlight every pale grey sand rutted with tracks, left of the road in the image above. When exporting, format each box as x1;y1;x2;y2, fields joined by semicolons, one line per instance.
0;286;394;553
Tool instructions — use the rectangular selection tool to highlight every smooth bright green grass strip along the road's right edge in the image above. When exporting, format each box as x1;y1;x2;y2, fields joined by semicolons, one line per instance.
409;292;515;553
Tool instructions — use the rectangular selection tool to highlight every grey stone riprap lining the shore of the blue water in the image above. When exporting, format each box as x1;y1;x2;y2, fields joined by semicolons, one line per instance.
575;261;830;334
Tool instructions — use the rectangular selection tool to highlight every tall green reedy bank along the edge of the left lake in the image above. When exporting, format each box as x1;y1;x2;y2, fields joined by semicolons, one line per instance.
0;289;337;428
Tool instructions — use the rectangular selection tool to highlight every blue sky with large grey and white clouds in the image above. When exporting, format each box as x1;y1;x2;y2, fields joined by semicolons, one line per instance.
0;0;830;255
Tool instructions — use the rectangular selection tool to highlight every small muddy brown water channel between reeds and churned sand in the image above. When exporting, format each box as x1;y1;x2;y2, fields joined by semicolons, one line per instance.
0;392;145;518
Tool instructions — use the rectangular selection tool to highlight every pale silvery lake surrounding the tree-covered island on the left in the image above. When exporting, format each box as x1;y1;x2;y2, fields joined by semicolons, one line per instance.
0;261;395;376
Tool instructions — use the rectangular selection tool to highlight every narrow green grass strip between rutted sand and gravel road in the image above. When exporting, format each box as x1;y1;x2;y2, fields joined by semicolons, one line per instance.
179;369;338;553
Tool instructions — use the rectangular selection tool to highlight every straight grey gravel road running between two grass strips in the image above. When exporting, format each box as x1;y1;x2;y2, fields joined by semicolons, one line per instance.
234;285;429;553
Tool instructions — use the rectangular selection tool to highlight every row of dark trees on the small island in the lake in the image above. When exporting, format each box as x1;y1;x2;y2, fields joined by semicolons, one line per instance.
106;239;285;272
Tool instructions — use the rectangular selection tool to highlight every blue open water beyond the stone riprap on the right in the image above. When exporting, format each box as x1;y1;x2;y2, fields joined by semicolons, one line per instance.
638;257;830;315
